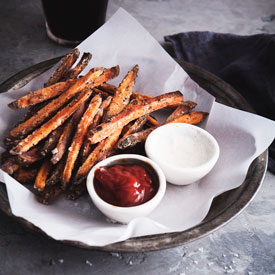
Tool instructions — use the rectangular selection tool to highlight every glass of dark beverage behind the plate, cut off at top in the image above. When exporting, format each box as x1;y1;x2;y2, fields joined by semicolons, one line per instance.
42;0;108;46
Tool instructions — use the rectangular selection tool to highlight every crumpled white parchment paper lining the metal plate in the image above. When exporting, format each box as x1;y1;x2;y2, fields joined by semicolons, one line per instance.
0;9;275;246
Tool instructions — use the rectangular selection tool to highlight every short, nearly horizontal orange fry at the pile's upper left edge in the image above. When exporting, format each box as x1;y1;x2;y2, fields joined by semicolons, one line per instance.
8;79;76;110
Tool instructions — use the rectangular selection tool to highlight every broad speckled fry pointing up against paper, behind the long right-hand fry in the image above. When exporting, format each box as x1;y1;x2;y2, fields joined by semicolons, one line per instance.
103;65;139;122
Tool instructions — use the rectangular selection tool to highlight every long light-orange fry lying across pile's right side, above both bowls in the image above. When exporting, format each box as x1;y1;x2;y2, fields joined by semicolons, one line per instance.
88;91;183;146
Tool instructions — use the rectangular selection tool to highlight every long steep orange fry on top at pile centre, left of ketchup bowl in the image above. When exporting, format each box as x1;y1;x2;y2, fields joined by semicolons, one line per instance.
62;95;102;189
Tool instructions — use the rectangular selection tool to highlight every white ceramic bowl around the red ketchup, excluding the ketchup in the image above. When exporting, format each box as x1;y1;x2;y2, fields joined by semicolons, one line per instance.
87;154;166;224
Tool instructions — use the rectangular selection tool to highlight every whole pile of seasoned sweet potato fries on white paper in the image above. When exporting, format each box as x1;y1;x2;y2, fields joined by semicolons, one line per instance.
1;49;207;204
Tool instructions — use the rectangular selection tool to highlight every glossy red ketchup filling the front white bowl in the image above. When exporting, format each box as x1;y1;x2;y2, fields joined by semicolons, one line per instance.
94;164;158;207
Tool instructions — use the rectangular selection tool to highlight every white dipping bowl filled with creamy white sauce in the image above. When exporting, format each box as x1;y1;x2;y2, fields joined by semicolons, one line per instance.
145;123;220;185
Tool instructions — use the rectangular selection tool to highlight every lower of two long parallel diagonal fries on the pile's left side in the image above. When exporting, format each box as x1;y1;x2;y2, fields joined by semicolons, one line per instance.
10;88;92;155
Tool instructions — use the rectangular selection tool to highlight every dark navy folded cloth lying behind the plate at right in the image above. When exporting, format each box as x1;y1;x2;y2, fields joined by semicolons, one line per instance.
164;32;275;174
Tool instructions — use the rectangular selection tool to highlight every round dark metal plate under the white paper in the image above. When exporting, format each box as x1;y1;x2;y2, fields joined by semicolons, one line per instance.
0;57;267;252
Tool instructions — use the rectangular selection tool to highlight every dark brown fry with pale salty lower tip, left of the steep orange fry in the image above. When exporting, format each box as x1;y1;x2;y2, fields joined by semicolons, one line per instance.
51;103;85;164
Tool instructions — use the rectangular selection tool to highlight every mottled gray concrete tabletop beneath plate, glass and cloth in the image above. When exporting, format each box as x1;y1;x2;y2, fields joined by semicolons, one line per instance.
0;0;275;275
